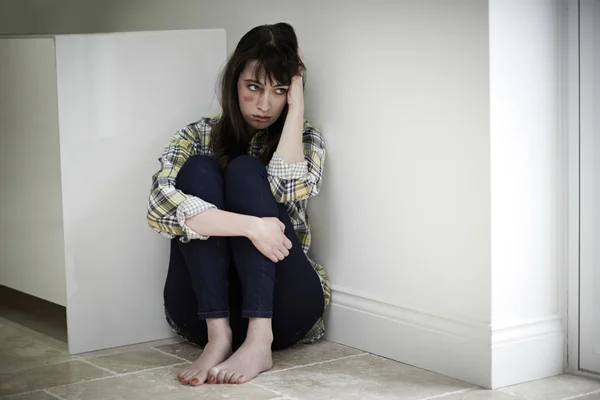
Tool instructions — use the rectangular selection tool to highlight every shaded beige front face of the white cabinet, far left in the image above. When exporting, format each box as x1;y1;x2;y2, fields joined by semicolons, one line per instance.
0;37;66;306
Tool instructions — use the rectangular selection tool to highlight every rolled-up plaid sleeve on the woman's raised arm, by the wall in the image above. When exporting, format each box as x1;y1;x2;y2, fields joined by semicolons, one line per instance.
267;123;326;203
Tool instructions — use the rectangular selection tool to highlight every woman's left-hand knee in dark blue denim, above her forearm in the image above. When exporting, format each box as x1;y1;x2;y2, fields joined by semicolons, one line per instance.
175;155;223;207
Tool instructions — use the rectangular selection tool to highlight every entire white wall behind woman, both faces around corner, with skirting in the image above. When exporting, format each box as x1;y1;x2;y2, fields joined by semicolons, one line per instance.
0;0;562;387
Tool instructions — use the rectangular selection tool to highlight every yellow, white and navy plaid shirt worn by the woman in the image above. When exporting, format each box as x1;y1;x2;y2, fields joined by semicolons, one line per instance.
147;118;331;342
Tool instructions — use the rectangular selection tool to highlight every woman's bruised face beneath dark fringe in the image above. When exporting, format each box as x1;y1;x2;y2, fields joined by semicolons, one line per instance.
237;61;289;130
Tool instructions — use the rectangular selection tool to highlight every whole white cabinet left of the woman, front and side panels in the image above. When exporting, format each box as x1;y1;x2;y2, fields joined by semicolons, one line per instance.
0;30;226;353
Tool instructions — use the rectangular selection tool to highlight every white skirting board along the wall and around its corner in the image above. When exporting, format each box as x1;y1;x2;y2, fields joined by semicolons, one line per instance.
326;288;563;389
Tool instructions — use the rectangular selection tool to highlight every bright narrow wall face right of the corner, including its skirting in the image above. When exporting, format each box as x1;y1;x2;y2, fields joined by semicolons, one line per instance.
490;0;565;386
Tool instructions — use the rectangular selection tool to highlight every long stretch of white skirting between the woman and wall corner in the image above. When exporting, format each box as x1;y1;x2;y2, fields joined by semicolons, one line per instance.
326;289;491;387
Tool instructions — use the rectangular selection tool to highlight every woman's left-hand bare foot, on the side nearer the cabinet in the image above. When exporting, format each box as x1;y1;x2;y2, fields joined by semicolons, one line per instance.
177;318;231;386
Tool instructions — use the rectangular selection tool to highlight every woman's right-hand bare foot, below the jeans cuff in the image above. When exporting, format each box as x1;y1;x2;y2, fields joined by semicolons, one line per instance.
208;318;273;383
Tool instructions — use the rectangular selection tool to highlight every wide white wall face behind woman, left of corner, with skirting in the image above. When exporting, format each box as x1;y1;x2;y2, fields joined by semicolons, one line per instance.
0;0;491;383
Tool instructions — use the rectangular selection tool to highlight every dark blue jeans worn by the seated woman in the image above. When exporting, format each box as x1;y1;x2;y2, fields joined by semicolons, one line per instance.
164;156;324;349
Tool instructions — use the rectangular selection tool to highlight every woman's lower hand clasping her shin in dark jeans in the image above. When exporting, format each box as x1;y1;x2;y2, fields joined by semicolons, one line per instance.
248;217;292;263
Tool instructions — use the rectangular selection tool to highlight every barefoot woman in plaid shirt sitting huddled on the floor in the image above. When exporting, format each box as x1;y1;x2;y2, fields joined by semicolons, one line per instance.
148;23;330;386
